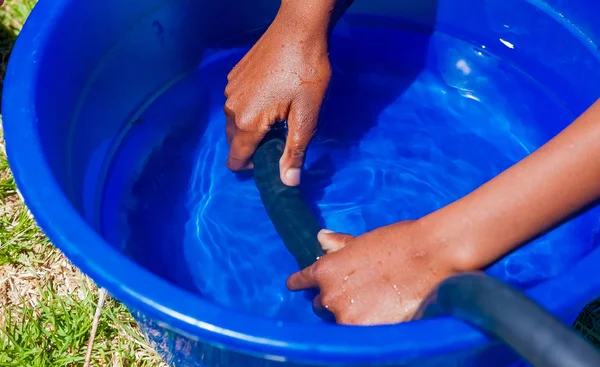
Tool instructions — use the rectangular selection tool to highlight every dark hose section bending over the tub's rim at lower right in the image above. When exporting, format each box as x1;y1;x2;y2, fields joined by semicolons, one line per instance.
415;273;600;367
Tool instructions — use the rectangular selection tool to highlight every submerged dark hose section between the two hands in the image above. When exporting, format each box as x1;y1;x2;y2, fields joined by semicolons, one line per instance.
252;123;324;269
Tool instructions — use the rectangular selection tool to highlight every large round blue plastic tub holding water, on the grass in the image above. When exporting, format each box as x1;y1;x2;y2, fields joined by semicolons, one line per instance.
3;0;600;367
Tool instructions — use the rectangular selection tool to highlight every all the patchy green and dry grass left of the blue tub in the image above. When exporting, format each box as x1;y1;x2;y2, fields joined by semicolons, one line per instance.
0;0;164;367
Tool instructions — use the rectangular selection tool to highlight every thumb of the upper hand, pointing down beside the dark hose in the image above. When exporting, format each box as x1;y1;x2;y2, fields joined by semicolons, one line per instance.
279;102;320;186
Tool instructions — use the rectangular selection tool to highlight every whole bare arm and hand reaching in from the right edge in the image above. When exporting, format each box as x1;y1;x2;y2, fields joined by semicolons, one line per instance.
288;100;600;324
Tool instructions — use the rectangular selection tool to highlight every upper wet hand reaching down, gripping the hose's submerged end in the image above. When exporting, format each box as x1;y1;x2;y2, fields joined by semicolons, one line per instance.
225;10;331;186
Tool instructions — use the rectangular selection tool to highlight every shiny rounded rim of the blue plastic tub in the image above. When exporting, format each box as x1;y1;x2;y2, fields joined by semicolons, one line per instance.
3;0;600;364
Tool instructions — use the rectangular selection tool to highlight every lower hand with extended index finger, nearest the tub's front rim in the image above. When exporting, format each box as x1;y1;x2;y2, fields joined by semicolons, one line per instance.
287;221;456;325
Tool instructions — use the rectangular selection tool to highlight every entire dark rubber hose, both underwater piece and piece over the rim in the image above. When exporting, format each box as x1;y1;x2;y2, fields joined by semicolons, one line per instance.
253;123;600;367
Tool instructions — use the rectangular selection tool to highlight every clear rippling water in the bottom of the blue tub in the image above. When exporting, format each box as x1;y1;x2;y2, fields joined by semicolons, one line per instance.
99;7;598;322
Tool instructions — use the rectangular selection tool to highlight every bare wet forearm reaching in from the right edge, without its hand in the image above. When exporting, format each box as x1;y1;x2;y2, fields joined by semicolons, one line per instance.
422;100;600;271
